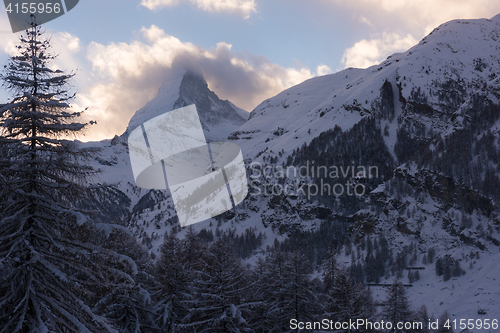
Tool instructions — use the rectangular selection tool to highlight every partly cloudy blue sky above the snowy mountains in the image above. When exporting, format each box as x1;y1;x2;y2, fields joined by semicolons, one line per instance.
0;0;500;141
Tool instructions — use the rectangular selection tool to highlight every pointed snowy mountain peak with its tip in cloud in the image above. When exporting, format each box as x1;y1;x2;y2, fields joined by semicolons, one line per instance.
127;68;248;141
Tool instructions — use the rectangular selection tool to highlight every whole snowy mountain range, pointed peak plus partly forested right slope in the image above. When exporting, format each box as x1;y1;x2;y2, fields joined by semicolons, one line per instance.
86;15;500;319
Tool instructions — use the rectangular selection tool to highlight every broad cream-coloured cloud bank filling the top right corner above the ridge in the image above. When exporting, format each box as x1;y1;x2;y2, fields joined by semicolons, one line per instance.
332;0;500;68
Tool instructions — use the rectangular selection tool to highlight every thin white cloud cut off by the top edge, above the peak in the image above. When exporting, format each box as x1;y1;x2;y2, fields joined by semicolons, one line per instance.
141;0;257;19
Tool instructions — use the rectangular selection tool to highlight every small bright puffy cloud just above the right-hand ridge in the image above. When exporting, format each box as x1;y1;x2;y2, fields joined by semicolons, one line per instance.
342;33;418;68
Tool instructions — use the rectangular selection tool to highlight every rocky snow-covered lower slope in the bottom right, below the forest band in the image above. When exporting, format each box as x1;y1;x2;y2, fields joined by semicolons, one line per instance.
348;165;500;322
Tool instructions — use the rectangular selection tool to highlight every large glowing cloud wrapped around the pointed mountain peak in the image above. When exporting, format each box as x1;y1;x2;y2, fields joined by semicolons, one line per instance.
75;25;322;139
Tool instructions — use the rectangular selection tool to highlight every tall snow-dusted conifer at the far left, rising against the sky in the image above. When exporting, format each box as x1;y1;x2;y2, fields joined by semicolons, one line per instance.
0;16;136;333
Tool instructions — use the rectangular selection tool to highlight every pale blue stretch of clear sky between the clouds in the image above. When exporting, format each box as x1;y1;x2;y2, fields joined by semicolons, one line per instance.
47;0;356;69
